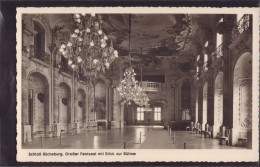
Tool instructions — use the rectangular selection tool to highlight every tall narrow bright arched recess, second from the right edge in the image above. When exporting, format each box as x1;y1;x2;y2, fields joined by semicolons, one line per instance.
213;71;224;137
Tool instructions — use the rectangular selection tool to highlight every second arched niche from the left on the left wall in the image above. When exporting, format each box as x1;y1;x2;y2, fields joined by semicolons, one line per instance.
58;82;71;132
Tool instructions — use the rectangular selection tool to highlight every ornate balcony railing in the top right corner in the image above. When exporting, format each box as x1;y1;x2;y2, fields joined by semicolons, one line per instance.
232;14;251;40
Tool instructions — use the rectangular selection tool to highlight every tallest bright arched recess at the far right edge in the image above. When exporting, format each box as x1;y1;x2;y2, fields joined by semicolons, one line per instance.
232;52;252;144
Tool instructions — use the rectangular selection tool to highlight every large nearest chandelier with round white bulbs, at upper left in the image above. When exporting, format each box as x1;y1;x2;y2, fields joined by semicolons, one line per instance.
59;14;118;76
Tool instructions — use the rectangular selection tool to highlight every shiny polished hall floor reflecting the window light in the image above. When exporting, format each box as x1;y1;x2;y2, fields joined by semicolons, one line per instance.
22;126;247;149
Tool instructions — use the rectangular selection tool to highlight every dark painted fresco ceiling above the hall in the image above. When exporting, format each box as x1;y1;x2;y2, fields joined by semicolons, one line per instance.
55;14;218;71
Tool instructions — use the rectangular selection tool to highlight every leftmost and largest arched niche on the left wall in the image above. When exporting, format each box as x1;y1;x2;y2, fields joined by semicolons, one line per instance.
27;72;49;136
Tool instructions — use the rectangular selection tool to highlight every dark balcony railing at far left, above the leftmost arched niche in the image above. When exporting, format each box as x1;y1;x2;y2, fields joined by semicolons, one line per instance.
29;46;51;64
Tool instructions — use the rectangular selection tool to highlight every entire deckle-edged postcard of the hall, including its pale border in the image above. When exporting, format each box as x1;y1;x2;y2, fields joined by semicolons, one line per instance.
17;7;259;162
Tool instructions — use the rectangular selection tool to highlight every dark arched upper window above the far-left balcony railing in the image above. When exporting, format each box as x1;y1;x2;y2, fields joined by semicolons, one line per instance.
33;21;45;52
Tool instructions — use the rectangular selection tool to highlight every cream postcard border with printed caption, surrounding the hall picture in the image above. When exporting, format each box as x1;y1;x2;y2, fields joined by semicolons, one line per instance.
16;7;259;162
